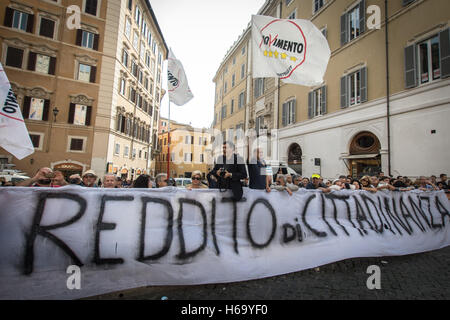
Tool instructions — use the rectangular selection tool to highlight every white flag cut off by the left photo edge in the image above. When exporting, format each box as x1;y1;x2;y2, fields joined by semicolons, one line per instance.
0;63;34;160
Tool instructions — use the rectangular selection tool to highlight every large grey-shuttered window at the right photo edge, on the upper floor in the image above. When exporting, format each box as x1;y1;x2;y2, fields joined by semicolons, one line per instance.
405;29;450;88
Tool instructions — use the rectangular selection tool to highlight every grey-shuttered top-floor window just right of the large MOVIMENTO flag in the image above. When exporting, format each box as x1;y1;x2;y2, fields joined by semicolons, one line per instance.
341;0;366;45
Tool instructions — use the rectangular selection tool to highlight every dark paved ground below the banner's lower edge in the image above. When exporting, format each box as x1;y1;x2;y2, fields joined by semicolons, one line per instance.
92;246;450;300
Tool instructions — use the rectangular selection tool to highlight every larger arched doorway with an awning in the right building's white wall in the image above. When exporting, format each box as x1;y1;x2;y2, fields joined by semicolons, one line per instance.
347;131;381;178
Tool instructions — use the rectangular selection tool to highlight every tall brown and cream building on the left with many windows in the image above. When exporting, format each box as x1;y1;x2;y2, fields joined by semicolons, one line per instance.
0;0;168;178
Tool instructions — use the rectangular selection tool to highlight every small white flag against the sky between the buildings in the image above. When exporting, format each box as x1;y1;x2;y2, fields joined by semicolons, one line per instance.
167;49;194;106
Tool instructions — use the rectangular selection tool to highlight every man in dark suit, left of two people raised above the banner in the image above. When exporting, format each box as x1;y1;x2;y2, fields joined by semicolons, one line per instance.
211;141;247;201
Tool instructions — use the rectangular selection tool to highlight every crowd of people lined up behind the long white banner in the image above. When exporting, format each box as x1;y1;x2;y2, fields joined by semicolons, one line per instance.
1;142;450;200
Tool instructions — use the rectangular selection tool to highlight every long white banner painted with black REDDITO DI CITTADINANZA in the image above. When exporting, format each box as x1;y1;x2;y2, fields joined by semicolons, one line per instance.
0;186;450;299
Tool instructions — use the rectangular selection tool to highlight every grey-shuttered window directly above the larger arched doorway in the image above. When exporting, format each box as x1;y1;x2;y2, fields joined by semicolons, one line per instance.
341;67;367;108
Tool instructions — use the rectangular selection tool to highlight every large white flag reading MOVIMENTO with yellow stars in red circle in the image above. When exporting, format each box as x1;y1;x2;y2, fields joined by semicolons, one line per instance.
252;15;330;86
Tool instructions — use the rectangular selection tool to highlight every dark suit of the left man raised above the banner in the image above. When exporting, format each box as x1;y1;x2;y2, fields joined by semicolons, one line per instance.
211;154;247;201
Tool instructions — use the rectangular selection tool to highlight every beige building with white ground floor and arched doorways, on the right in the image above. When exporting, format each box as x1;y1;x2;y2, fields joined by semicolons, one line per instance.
215;0;450;178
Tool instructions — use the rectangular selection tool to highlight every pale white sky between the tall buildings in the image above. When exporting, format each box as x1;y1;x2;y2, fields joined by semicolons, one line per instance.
150;0;265;128
